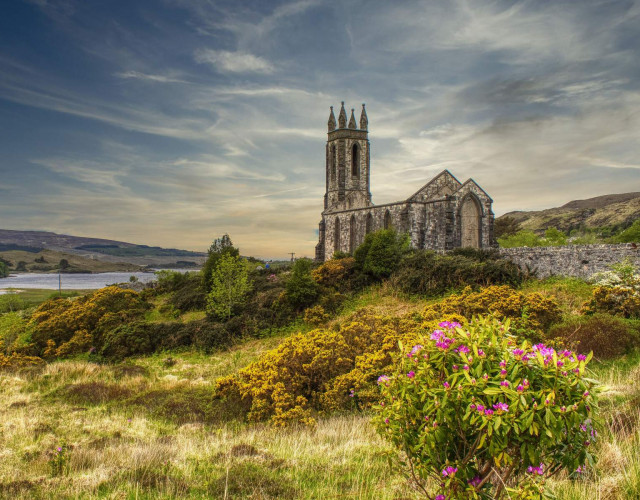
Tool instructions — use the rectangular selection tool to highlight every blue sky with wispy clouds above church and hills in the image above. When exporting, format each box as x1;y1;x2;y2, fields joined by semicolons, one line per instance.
0;0;640;257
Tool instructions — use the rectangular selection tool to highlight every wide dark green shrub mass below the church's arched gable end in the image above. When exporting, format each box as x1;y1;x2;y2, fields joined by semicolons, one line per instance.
392;249;524;295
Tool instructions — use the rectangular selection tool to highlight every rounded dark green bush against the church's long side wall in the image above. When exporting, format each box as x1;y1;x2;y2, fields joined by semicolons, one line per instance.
354;229;409;279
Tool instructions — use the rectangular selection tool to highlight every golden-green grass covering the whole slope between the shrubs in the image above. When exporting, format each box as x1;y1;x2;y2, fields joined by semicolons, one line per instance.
0;280;640;500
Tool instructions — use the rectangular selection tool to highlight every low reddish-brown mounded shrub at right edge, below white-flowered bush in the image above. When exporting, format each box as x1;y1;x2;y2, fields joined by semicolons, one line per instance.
548;313;640;359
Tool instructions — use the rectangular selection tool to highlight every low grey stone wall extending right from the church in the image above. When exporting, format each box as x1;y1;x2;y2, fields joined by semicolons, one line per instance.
499;243;640;278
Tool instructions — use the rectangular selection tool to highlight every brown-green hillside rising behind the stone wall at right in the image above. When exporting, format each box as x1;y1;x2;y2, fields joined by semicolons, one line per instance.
496;193;640;233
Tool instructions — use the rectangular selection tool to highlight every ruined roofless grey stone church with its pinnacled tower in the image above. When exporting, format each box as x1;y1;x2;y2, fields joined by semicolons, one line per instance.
316;102;494;261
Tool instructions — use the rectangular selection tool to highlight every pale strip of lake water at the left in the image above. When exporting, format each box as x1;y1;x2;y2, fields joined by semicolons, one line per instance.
0;270;168;293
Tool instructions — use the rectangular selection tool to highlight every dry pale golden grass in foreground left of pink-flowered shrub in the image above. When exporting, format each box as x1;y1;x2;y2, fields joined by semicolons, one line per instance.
0;357;422;499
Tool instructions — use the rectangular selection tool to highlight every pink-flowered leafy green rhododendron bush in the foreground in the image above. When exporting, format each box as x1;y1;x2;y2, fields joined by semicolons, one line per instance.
374;317;597;499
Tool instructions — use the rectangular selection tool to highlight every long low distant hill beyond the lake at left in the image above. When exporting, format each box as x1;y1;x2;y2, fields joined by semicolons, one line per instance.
0;229;206;267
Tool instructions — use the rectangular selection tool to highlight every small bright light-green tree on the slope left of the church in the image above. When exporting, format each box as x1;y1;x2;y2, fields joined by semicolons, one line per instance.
207;253;251;319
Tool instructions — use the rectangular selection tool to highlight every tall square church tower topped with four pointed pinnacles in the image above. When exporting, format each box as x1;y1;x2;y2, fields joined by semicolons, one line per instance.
324;101;371;212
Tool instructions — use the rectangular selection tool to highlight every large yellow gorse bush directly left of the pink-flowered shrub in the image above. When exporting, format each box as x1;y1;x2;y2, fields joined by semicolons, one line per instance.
217;310;428;426
